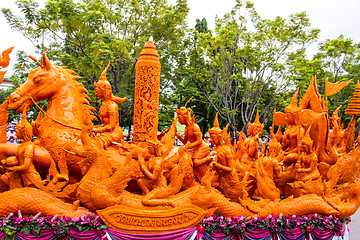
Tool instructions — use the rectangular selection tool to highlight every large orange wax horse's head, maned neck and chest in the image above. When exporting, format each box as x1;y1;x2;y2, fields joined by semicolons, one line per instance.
8;53;95;181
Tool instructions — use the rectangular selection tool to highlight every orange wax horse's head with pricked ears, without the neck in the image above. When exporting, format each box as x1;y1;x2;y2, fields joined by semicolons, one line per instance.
8;53;59;112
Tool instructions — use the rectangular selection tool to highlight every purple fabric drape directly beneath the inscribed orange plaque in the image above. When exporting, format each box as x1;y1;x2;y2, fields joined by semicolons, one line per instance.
108;227;196;240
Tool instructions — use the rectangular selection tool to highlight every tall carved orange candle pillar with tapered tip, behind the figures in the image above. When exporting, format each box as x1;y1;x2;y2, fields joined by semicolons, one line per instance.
133;39;161;142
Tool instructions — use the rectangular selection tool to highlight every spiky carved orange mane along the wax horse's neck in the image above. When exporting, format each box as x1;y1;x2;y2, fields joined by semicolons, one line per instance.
52;65;96;121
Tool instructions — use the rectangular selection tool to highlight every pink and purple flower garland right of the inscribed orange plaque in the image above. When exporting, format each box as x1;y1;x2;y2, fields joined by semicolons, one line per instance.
198;214;351;235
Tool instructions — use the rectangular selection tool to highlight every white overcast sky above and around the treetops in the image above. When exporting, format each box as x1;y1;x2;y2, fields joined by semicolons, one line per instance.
0;0;360;76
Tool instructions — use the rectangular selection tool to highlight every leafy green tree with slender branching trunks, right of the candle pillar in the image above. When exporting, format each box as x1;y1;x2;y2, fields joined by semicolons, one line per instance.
181;0;319;135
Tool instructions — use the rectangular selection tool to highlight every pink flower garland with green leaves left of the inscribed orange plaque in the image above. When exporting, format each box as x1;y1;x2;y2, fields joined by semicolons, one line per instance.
0;210;108;237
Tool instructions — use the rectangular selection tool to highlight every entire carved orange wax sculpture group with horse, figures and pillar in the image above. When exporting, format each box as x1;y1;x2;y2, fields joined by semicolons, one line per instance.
0;41;360;233
